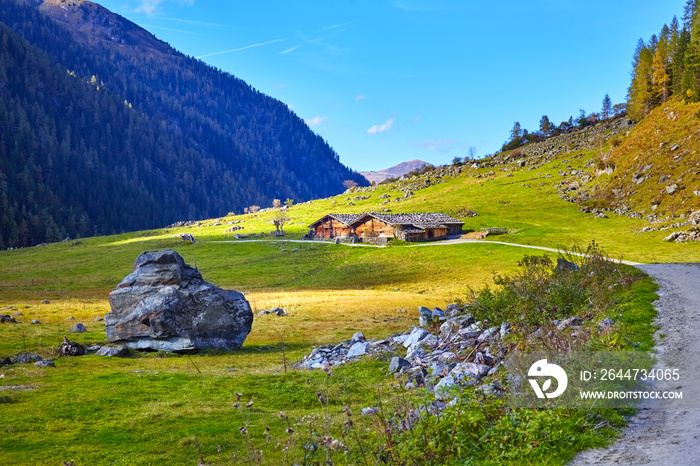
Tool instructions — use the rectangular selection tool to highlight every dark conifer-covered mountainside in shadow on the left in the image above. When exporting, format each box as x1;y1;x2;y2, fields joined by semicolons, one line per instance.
0;0;368;249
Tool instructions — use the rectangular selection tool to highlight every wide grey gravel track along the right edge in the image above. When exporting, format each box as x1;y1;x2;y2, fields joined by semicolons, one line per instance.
570;263;700;466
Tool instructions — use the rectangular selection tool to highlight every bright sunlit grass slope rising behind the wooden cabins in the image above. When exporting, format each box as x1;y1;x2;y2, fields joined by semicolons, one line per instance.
63;146;700;262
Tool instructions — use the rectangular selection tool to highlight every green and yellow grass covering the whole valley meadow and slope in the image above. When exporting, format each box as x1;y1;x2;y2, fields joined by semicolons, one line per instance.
0;109;700;464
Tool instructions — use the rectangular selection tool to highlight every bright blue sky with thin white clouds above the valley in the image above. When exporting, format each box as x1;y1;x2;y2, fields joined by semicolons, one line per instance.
98;0;685;170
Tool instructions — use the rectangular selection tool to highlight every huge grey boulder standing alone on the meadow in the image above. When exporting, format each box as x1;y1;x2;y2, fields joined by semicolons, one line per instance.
105;249;253;352
